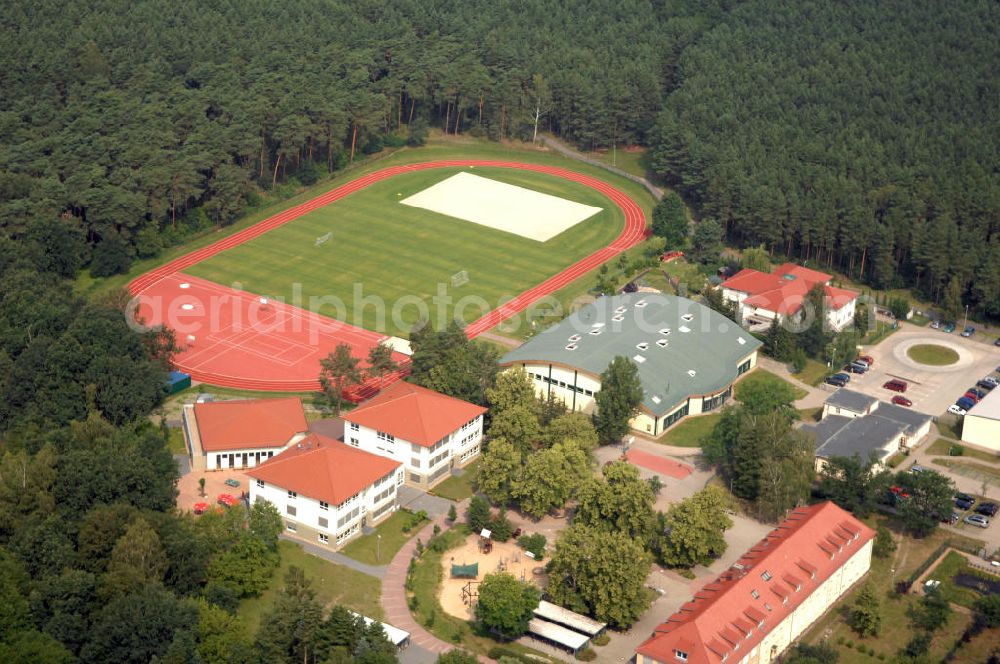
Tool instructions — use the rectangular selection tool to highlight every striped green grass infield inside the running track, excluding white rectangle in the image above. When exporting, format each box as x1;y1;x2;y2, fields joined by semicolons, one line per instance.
187;168;624;337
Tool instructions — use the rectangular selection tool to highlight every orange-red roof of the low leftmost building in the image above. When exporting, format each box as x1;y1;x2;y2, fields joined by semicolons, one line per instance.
194;397;309;452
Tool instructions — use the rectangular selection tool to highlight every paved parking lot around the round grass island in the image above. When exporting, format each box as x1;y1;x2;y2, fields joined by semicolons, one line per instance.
848;323;1000;416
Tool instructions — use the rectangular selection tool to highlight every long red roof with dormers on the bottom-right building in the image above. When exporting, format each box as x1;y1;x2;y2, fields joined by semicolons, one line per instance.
636;502;875;664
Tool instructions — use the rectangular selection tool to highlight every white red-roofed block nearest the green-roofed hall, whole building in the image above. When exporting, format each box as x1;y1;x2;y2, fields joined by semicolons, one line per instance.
342;382;486;489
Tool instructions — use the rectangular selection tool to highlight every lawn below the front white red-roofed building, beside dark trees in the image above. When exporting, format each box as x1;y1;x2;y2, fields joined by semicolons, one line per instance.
237;540;382;634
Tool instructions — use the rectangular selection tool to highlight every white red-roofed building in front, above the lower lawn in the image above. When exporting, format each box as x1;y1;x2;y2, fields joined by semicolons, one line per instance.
247;433;403;548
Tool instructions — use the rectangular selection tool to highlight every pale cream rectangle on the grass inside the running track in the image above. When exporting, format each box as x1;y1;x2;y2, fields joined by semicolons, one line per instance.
400;173;601;242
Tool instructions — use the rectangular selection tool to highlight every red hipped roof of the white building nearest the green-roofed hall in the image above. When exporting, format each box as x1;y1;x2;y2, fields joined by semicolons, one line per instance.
343;382;486;447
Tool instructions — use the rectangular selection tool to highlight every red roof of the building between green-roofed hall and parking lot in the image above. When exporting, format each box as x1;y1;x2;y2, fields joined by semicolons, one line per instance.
722;263;858;316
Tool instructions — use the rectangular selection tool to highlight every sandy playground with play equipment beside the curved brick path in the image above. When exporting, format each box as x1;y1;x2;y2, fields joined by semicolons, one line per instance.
438;533;547;620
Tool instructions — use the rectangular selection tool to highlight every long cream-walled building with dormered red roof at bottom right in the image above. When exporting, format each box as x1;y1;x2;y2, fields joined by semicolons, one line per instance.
636;502;875;664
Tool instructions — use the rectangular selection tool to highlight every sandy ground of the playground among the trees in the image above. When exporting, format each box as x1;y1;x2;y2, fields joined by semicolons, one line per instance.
438;535;546;620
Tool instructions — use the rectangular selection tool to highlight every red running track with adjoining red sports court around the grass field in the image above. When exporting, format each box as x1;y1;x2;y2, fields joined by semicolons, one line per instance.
128;160;646;398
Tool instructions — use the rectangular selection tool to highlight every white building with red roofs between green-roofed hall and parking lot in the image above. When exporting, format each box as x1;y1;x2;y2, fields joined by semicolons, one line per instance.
720;263;858;331
